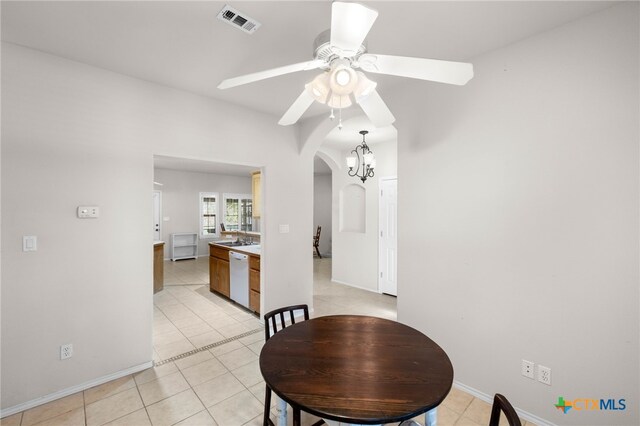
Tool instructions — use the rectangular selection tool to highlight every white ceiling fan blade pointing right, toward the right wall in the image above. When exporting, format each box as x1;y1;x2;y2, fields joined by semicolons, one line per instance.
358;54;473;86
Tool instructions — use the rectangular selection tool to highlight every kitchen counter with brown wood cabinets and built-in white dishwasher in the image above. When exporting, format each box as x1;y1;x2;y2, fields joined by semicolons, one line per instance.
209;240;261;314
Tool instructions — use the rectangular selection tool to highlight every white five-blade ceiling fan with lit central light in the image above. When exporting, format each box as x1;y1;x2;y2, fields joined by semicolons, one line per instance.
218;1;473;127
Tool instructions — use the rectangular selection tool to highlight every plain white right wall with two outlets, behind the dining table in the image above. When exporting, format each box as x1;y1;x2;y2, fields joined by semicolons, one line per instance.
392;2;640;425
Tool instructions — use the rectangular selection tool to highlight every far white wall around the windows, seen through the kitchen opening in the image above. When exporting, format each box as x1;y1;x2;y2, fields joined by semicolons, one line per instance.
153;169;251;259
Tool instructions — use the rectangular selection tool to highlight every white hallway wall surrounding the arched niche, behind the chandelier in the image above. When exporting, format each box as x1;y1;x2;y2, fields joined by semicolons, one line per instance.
332;141;397;291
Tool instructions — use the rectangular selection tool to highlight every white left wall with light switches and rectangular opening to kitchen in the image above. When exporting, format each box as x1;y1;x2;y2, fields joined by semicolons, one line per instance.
1;43;313;414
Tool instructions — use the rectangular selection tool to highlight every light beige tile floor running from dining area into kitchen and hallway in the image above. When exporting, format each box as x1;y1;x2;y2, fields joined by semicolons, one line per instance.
1;258;531;426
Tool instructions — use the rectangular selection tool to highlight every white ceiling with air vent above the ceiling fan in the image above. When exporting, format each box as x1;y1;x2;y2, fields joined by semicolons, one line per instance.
1;0;614;125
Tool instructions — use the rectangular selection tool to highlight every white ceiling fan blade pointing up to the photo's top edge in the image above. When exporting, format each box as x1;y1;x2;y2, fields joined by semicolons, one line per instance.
330;1;378;57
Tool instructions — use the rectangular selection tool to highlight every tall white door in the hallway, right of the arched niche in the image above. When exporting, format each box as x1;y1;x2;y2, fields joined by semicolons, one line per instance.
378;178;398;296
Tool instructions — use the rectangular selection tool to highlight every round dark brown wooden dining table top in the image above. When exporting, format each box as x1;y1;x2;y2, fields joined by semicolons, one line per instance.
260;315;453;424
